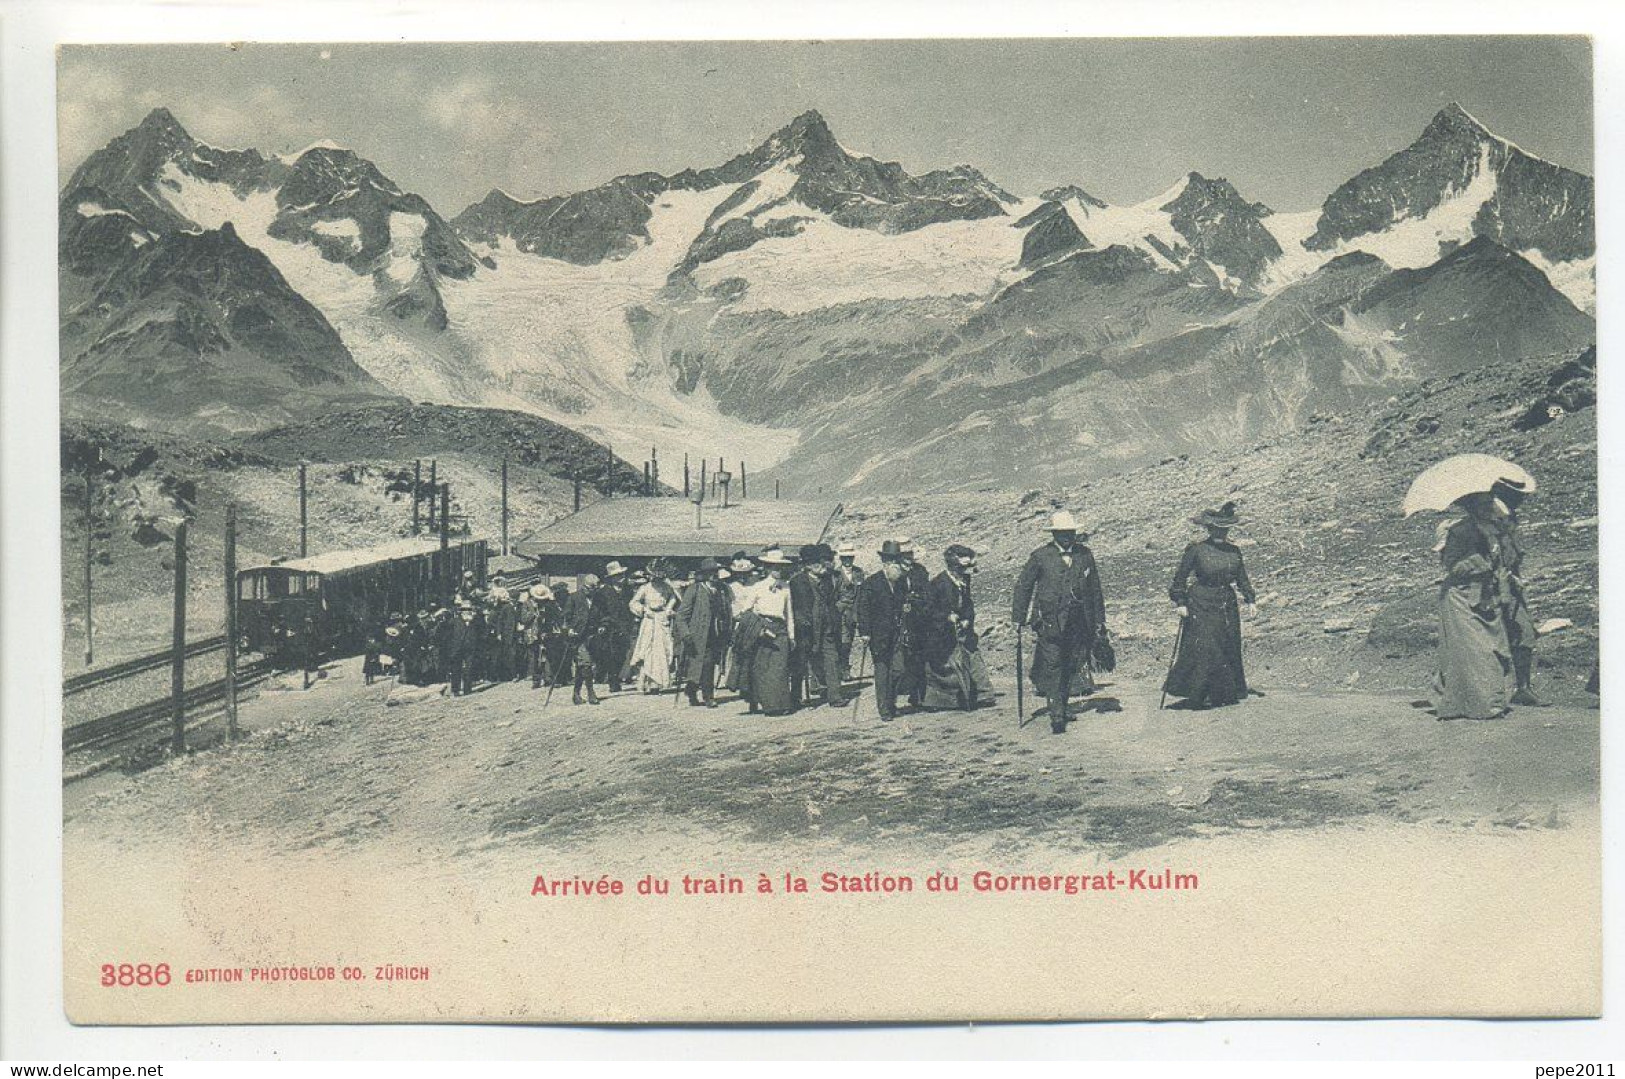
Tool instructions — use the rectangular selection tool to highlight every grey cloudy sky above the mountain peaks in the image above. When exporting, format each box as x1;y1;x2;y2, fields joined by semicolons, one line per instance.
59;37;1593;216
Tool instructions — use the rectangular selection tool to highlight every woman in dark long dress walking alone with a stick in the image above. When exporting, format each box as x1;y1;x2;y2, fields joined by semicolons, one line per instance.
1164;502;1256;709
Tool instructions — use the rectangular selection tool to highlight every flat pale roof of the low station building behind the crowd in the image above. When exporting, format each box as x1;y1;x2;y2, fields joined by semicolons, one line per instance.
512;497;840;559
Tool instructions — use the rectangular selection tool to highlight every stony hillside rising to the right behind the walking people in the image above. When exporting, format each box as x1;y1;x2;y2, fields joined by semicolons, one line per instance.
825;341;1599;702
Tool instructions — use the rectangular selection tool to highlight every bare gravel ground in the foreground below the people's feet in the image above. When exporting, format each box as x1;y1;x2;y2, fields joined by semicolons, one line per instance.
67;650;1597;858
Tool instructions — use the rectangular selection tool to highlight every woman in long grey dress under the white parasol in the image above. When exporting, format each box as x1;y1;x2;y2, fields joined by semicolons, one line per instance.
1433;492;1513;720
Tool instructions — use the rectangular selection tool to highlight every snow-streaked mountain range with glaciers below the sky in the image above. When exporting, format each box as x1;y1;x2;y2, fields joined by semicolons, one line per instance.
62;99;1593;489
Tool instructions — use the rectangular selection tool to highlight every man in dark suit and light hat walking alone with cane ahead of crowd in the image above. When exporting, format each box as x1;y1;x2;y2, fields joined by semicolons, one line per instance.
1011;510;1107;735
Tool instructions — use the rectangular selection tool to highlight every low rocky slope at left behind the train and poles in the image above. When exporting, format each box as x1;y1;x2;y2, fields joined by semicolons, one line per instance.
60;406;642;671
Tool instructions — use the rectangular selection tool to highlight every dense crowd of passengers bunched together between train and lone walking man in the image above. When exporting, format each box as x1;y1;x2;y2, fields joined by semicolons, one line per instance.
362;540;993;720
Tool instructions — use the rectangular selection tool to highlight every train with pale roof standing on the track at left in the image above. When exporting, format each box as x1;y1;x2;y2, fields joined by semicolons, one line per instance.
237;538;489;668
